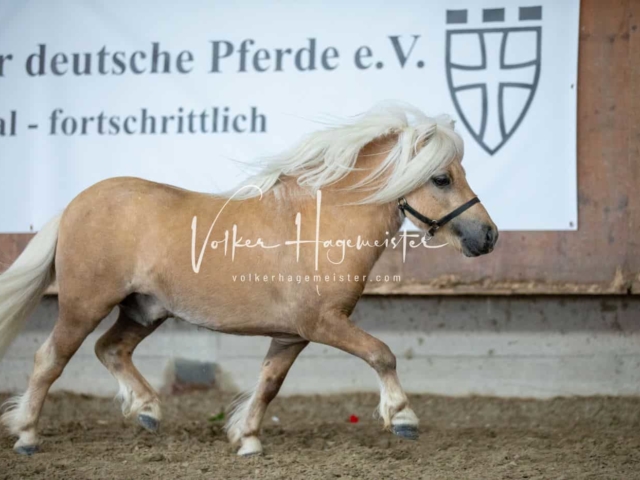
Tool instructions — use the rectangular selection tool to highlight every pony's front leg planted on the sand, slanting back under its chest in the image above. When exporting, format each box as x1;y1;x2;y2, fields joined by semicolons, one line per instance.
225;338;309;456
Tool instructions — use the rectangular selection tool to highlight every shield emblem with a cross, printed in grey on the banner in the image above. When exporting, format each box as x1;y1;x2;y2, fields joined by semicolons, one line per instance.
446;15;542;155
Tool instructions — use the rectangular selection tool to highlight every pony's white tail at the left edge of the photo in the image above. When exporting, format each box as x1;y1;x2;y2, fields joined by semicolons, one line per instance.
0;215;61;359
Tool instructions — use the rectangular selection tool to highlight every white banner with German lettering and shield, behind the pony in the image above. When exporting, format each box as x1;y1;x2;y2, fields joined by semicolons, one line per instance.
0;0;579;232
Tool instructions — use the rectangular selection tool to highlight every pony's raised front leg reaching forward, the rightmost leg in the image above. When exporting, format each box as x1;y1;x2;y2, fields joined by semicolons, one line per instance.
305;312;419;440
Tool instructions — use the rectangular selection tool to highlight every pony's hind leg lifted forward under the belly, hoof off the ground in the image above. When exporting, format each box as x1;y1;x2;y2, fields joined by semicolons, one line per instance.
95;308;164;432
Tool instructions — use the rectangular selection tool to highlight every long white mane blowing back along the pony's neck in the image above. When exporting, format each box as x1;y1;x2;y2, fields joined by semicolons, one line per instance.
227;103;464;203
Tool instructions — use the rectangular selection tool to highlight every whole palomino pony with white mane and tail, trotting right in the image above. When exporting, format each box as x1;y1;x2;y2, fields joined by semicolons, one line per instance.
0;105;498;455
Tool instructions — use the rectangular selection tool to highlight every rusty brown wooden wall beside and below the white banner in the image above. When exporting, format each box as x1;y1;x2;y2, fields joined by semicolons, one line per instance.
0;0;640;294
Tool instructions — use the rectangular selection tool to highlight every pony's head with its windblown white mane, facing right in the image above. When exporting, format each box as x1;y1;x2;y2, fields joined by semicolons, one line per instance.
236;103;498;257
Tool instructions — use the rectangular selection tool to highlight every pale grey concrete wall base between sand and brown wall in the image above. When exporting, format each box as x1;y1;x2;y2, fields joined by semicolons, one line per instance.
0;296;640;398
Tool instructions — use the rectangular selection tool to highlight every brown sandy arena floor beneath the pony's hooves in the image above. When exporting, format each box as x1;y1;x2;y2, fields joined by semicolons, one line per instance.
0;392;640;480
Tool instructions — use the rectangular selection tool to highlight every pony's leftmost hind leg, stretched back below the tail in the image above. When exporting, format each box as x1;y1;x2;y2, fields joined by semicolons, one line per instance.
1;302;110;455
